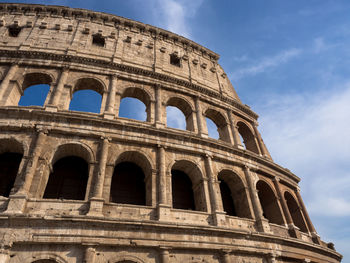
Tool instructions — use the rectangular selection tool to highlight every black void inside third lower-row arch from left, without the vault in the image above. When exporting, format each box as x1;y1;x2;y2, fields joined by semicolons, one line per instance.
110;162;146;205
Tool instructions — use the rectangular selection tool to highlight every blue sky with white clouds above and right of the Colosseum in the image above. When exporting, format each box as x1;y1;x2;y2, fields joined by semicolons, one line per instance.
6;0;350;263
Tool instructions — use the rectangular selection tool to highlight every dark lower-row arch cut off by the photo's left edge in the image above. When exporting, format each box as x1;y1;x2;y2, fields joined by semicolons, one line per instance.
0;138;24;197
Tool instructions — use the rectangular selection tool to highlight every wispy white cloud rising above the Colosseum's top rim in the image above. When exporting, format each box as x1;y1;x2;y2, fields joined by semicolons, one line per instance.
153;0;203;37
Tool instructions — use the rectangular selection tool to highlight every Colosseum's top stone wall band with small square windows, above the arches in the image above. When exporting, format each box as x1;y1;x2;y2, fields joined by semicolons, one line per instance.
0;3;240;102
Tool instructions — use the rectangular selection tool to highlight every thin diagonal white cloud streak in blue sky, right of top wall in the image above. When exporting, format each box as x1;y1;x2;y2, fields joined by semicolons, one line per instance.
231;48;301;80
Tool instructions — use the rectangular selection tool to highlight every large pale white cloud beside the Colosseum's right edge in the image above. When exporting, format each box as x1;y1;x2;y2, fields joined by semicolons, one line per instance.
257;83;350;220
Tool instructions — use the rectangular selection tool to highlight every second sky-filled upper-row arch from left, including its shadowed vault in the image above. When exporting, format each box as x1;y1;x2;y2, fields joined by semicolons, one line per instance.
69;78;104;113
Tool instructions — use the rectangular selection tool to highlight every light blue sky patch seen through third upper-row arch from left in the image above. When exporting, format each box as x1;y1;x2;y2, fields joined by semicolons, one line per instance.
119;97;147;121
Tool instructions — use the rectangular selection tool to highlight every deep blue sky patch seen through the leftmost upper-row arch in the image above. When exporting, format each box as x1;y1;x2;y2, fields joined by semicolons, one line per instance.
18;84;50;106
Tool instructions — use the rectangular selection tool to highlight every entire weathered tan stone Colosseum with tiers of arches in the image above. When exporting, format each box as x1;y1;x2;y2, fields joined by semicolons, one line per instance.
0;3;341;263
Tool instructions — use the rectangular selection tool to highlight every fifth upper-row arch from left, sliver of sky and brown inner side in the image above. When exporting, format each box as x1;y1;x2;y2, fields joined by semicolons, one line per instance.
204;109;230;142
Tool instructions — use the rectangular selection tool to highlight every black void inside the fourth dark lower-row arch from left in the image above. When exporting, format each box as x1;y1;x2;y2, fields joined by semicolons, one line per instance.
171;170;195;210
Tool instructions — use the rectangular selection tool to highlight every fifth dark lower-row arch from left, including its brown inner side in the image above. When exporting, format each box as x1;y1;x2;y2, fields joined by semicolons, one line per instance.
218;169;253;218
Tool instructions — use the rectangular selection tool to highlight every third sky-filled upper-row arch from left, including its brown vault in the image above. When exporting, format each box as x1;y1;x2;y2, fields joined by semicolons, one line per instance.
119;87;151;121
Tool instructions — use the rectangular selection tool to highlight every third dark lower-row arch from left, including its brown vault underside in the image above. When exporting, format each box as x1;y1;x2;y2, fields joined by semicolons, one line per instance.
110;151;152;205
